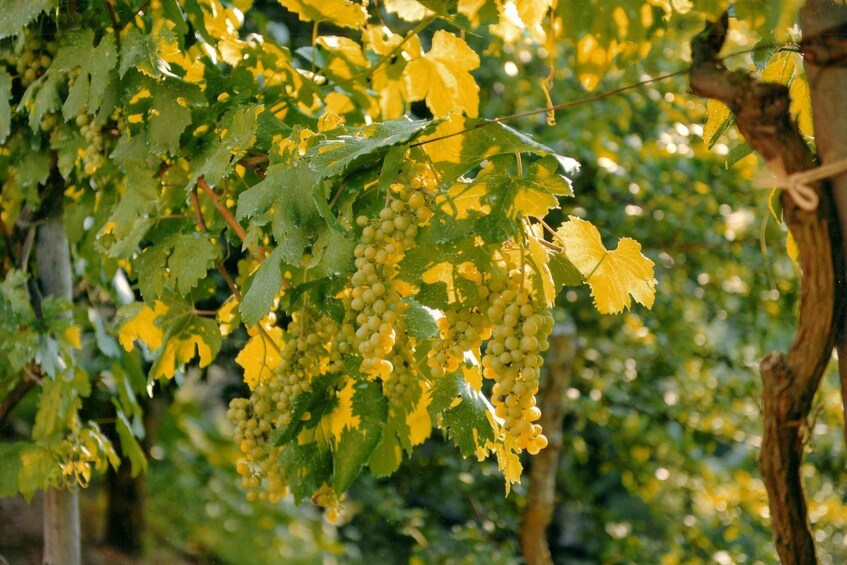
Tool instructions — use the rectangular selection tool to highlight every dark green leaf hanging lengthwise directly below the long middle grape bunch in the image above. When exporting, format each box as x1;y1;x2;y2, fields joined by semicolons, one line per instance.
332;382;388;492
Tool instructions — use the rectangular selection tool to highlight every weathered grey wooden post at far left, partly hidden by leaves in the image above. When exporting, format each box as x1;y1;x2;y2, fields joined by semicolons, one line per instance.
34;213;82;565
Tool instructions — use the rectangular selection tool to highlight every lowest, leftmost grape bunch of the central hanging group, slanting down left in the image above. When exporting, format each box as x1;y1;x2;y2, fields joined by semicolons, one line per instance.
227;313;344;501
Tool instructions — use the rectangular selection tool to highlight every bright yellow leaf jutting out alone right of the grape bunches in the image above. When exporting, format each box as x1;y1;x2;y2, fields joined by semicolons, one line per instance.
556;216;656;314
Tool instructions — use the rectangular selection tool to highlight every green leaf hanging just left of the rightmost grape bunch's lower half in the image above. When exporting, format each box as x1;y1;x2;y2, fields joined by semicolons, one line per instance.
429;373;494;457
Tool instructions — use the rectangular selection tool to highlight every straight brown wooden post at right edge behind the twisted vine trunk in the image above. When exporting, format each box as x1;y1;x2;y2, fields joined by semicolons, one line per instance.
800;0;847;448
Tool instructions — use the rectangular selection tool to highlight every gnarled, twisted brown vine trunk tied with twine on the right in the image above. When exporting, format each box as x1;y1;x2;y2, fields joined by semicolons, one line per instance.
691;14;840;565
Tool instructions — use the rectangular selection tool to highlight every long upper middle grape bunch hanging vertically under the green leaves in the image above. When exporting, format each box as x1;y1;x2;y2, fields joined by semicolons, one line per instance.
345;161;435;380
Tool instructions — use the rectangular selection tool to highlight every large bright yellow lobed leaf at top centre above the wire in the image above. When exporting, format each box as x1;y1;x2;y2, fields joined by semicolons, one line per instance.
403;30;479;118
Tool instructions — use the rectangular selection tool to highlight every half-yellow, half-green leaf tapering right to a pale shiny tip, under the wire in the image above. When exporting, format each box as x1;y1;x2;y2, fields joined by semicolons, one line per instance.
420;115;579;182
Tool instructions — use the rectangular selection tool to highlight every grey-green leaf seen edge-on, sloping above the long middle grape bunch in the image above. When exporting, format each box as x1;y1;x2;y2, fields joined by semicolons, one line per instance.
309;118;430;180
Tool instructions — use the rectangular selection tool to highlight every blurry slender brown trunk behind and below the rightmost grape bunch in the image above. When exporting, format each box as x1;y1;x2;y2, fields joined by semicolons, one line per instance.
520;325;576;565
